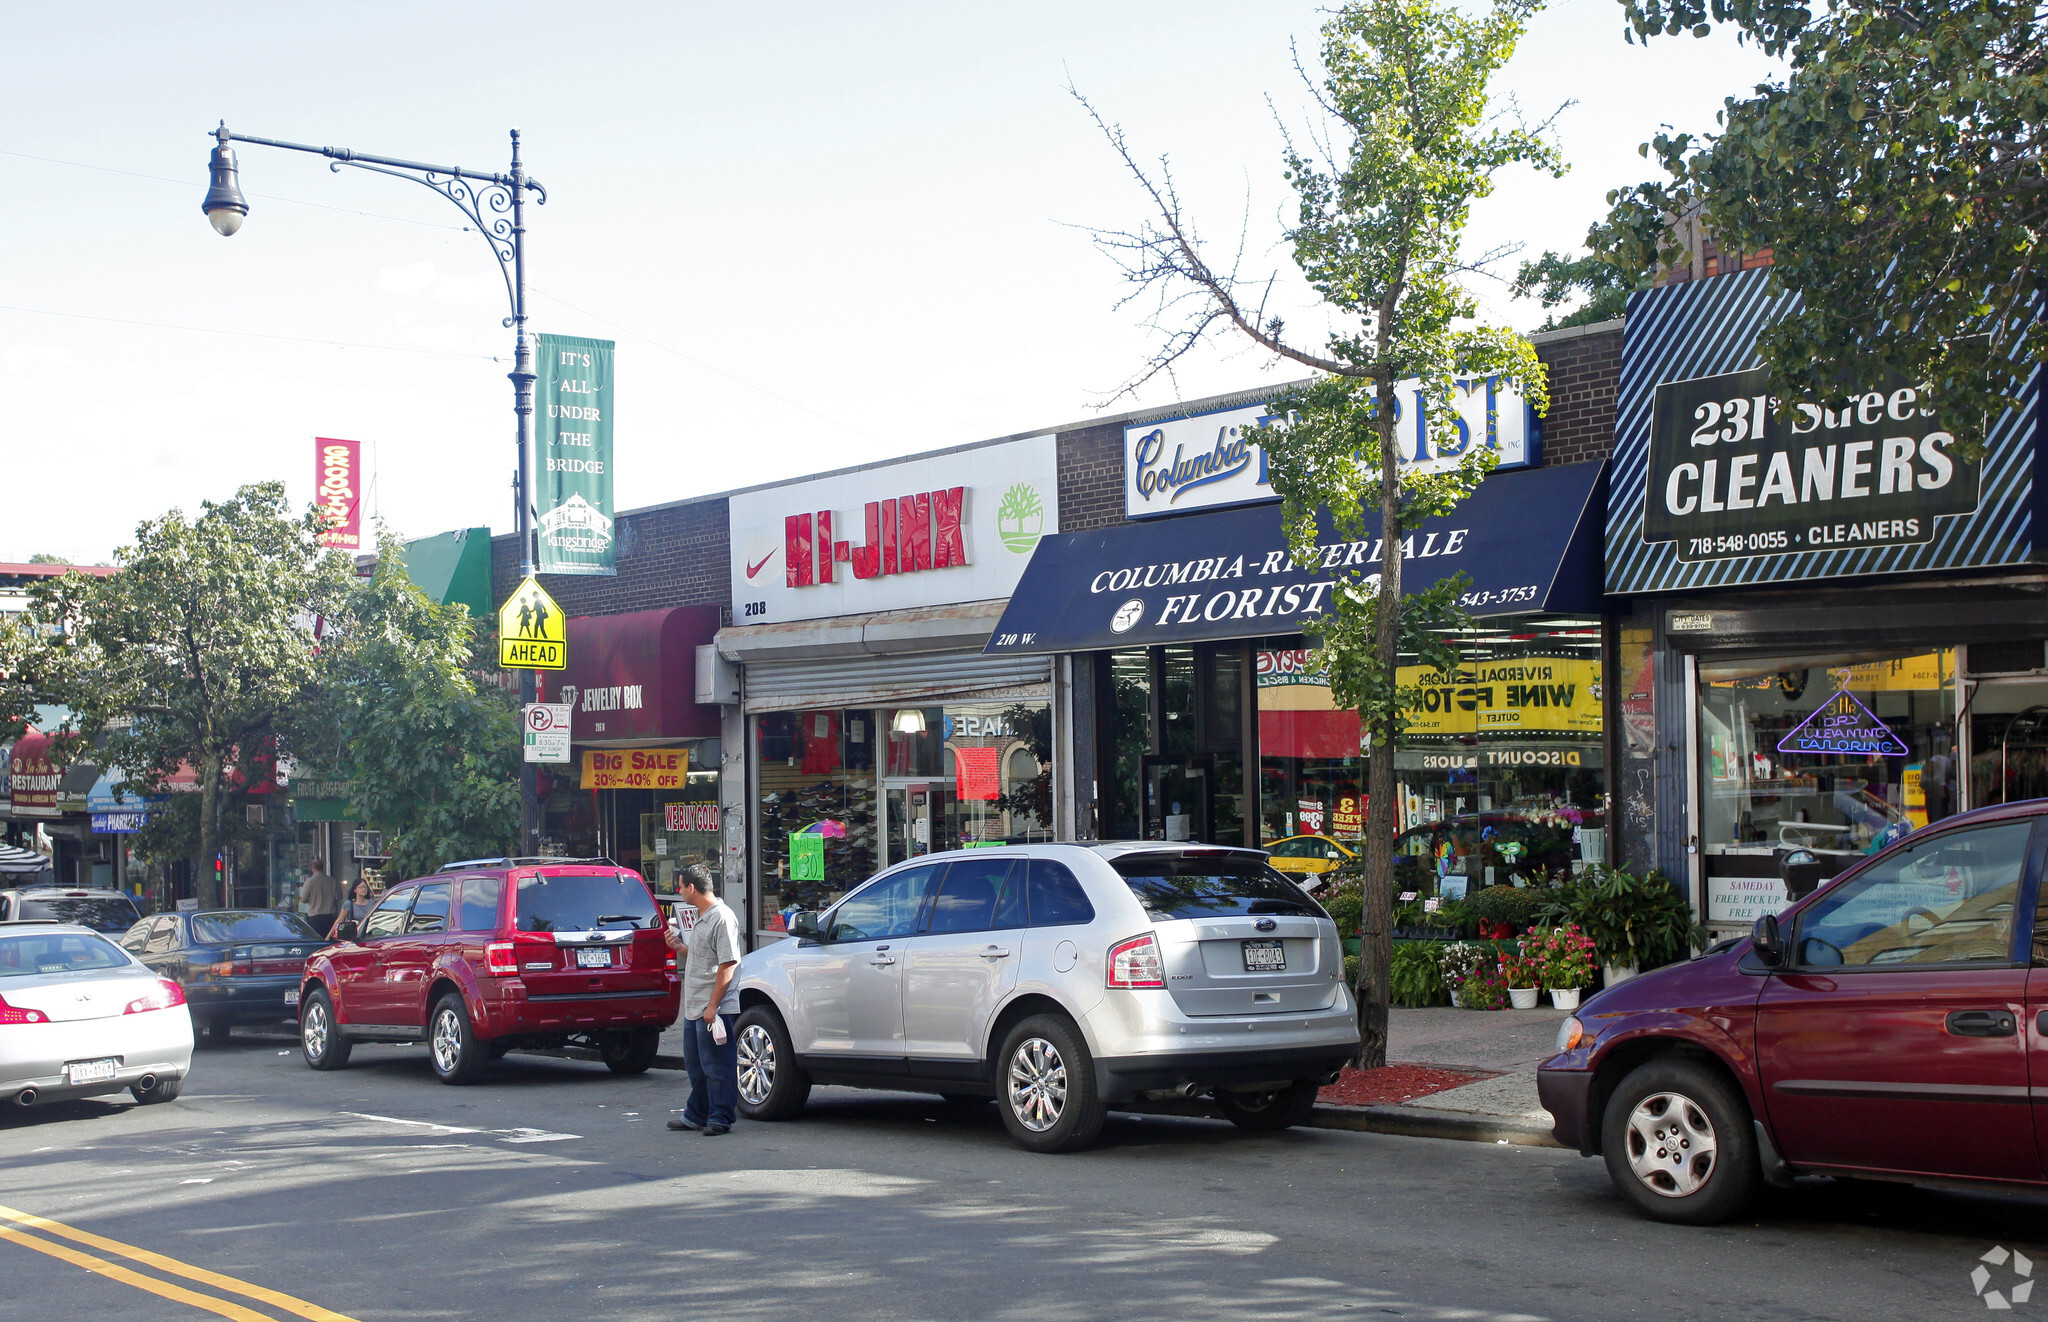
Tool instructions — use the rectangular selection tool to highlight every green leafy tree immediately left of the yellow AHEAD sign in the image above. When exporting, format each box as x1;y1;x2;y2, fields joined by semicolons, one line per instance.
305;536;520;876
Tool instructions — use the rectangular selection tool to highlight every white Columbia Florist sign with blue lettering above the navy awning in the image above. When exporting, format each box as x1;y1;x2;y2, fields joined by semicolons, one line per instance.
1124;377;1540;518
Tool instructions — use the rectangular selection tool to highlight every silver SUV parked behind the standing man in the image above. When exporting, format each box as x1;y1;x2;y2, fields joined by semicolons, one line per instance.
739;843;1358;1152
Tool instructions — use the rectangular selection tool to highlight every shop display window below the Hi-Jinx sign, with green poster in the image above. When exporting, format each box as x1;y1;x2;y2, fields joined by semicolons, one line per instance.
761;702;1053;931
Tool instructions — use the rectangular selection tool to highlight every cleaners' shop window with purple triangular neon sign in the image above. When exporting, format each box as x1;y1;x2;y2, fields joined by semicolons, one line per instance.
1700;651;1958;923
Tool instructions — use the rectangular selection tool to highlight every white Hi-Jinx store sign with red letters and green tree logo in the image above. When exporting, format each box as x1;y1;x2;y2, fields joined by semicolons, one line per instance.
729;436;1059;624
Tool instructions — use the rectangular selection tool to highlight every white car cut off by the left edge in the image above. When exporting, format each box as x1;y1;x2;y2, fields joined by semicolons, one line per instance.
0;923;193;1107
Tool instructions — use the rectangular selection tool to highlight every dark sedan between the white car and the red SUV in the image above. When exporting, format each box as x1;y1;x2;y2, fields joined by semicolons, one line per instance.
121;909;326;1044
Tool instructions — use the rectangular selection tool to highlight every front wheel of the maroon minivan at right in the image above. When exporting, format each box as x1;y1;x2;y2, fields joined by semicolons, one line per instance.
1599;1058;1759;1226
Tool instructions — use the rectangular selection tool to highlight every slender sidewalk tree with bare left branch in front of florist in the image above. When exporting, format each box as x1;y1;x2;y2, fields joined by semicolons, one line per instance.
1083;0;1563;1066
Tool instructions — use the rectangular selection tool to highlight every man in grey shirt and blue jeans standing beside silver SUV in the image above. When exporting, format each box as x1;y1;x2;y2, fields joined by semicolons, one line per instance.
662;864;739;1138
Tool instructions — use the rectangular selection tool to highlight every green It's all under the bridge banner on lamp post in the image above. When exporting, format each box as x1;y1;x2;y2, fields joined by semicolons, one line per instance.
535;336;618;575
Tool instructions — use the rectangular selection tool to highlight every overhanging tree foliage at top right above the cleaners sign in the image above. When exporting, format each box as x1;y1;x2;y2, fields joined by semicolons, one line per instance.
1593;0;2048;452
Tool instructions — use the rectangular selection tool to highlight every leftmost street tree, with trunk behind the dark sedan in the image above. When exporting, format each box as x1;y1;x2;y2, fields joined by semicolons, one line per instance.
0;483;352;905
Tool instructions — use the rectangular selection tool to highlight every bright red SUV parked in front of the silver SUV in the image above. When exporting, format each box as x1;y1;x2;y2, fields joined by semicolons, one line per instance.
299;860;682;1083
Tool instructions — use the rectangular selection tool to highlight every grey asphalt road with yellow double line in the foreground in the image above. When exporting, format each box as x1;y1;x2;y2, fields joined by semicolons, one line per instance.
0;1038;2048;1322
